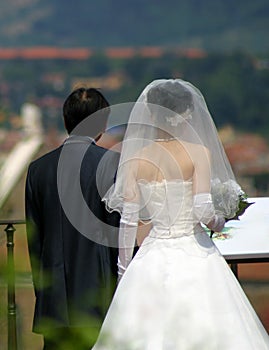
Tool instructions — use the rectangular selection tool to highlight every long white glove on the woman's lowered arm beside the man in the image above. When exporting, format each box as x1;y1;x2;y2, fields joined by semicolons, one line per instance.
118;202;139;282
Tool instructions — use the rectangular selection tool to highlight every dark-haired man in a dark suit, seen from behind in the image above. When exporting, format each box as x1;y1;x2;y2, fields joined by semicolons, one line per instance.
25;88;119;350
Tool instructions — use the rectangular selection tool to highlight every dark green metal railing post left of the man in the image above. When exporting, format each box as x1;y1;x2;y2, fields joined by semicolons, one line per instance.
5;223;17;350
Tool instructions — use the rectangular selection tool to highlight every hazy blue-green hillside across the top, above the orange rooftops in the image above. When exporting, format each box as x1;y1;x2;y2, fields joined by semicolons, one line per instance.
0;0;269;53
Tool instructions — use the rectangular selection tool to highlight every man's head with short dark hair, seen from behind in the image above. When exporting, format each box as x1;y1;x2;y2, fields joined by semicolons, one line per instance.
63;87;110;137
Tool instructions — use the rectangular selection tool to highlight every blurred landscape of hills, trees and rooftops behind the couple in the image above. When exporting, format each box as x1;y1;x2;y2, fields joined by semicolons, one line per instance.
0;0;269;350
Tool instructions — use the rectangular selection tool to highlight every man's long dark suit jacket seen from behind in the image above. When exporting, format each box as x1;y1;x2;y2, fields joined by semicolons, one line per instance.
25;137;120;333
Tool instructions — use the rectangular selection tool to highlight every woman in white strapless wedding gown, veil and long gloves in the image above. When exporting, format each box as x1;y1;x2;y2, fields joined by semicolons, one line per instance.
93;79;269;350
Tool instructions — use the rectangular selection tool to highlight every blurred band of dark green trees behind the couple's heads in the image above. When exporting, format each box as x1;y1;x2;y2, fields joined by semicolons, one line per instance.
0;51;269;138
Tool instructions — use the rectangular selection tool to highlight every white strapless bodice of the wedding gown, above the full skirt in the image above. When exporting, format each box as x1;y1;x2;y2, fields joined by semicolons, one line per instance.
139;180;197;238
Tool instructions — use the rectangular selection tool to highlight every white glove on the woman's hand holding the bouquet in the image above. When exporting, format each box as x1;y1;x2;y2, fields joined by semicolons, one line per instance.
193;193;225;232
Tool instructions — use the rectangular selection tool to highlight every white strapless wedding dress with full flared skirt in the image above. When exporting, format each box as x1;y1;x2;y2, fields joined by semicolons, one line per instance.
93;180;269;350
